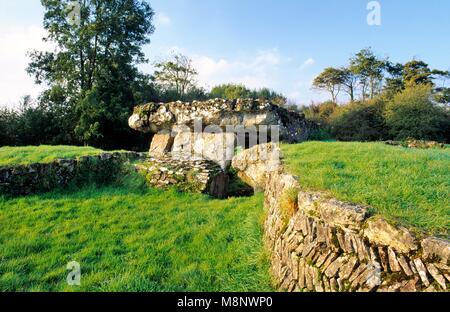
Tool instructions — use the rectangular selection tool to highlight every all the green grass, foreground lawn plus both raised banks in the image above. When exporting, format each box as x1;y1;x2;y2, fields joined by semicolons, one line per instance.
0;142;450;291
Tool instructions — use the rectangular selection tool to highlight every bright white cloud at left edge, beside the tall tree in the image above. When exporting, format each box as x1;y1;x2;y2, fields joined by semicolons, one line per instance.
0;26;52;107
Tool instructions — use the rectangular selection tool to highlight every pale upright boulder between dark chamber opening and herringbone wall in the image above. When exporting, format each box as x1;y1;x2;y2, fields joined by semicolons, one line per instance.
231;143;281;191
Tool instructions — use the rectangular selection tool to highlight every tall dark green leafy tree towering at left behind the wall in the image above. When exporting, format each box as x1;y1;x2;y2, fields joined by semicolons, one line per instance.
28;0;154;148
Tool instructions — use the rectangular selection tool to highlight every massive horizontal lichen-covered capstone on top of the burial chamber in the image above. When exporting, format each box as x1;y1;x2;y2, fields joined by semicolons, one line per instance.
129;99;315;142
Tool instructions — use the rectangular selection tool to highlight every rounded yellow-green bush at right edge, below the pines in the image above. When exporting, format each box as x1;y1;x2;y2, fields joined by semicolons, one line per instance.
385;85;450;141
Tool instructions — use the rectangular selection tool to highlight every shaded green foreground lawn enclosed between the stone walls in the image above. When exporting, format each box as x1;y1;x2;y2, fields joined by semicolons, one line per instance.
0;174;272;291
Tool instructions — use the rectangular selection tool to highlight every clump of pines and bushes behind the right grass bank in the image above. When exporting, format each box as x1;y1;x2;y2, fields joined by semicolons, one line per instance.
303;49;450;142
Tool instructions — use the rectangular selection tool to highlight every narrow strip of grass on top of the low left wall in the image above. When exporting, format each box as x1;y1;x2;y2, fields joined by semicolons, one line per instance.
0;145;102;166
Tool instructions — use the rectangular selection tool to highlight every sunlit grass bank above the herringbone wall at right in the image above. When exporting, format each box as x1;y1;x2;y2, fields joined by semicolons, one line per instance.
282;142;450;237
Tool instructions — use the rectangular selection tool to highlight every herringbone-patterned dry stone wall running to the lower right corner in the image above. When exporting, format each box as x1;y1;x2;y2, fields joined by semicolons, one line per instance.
264;171;450;292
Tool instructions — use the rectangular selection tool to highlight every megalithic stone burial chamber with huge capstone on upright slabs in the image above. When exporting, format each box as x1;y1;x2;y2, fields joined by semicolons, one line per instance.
129;99;315;197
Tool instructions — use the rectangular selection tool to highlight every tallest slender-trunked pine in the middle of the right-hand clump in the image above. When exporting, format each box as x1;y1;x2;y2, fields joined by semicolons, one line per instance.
349;48;386;101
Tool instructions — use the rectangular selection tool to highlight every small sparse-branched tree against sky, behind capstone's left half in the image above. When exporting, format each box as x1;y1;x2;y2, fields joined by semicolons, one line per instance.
154;54;198;98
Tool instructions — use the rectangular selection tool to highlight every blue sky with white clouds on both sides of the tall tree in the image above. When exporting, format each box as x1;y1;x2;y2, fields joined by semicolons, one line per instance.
0;0;450;107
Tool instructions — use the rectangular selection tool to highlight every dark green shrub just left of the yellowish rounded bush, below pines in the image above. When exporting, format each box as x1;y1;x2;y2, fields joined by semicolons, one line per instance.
330;99;386;141
